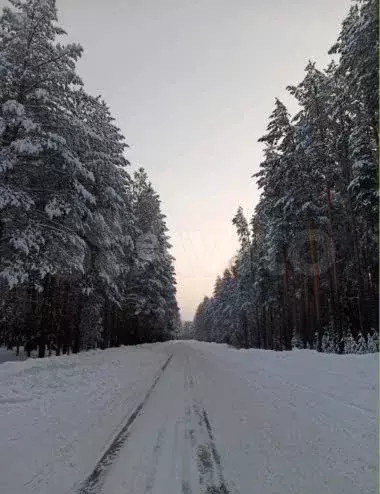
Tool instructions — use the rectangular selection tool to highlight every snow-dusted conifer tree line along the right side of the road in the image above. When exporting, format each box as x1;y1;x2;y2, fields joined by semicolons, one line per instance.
193;0;379;353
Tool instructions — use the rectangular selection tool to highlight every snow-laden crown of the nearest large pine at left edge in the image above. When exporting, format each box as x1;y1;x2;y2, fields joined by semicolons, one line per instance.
0;0;90;286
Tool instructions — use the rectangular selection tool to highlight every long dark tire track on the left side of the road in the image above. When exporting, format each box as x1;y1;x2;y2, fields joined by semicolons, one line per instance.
77;354;173;494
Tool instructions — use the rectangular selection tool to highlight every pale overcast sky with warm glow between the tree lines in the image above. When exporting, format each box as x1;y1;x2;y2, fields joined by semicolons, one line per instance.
0;0;350;319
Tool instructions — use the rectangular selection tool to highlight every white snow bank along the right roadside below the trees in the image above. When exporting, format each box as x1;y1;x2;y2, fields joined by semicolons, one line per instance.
184;340;378;416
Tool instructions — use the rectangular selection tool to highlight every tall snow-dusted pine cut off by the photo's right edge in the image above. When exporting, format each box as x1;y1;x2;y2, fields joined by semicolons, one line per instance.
330;0;379;332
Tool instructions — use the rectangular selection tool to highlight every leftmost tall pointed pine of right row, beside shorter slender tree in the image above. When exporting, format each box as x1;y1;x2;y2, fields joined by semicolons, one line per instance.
254;98;295;349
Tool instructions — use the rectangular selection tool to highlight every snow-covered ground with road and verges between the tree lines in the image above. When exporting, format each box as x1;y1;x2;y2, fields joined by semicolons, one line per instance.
0;342;377;494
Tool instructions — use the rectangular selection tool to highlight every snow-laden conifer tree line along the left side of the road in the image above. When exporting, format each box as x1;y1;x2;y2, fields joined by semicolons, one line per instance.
0;0;179;357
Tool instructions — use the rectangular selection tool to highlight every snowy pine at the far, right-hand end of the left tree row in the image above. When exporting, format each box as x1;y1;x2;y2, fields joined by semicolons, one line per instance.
126;169;179;342
